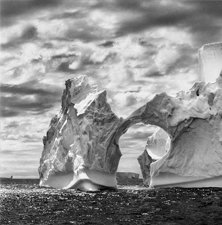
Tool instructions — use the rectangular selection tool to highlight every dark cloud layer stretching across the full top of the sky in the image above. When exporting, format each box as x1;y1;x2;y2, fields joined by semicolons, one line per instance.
1;0;222;47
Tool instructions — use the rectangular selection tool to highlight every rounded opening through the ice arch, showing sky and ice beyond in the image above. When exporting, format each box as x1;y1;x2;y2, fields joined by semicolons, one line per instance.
117;122;171;186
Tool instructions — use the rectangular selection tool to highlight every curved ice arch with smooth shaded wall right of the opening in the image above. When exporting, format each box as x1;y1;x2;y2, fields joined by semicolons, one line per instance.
107;90;222;186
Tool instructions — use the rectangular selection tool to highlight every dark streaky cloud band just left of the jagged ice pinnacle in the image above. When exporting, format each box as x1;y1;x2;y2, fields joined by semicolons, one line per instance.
0;81;61;117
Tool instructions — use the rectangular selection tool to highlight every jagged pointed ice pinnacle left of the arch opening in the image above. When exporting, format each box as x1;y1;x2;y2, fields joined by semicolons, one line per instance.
39;76;121;191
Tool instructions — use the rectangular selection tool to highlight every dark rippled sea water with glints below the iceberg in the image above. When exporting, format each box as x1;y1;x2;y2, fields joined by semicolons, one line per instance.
0;179;222;225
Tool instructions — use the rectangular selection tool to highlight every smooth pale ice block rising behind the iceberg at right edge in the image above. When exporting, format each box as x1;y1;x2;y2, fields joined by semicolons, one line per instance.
199;43;222;83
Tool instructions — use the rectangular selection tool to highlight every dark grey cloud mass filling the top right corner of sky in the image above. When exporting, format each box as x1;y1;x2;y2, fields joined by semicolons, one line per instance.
112;0;222;47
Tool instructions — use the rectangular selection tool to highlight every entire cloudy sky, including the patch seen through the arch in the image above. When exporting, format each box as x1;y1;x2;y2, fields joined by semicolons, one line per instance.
0;0;222;177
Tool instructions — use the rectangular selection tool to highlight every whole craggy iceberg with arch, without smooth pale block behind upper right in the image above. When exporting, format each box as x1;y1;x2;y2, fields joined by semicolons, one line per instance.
39;43;222;191
